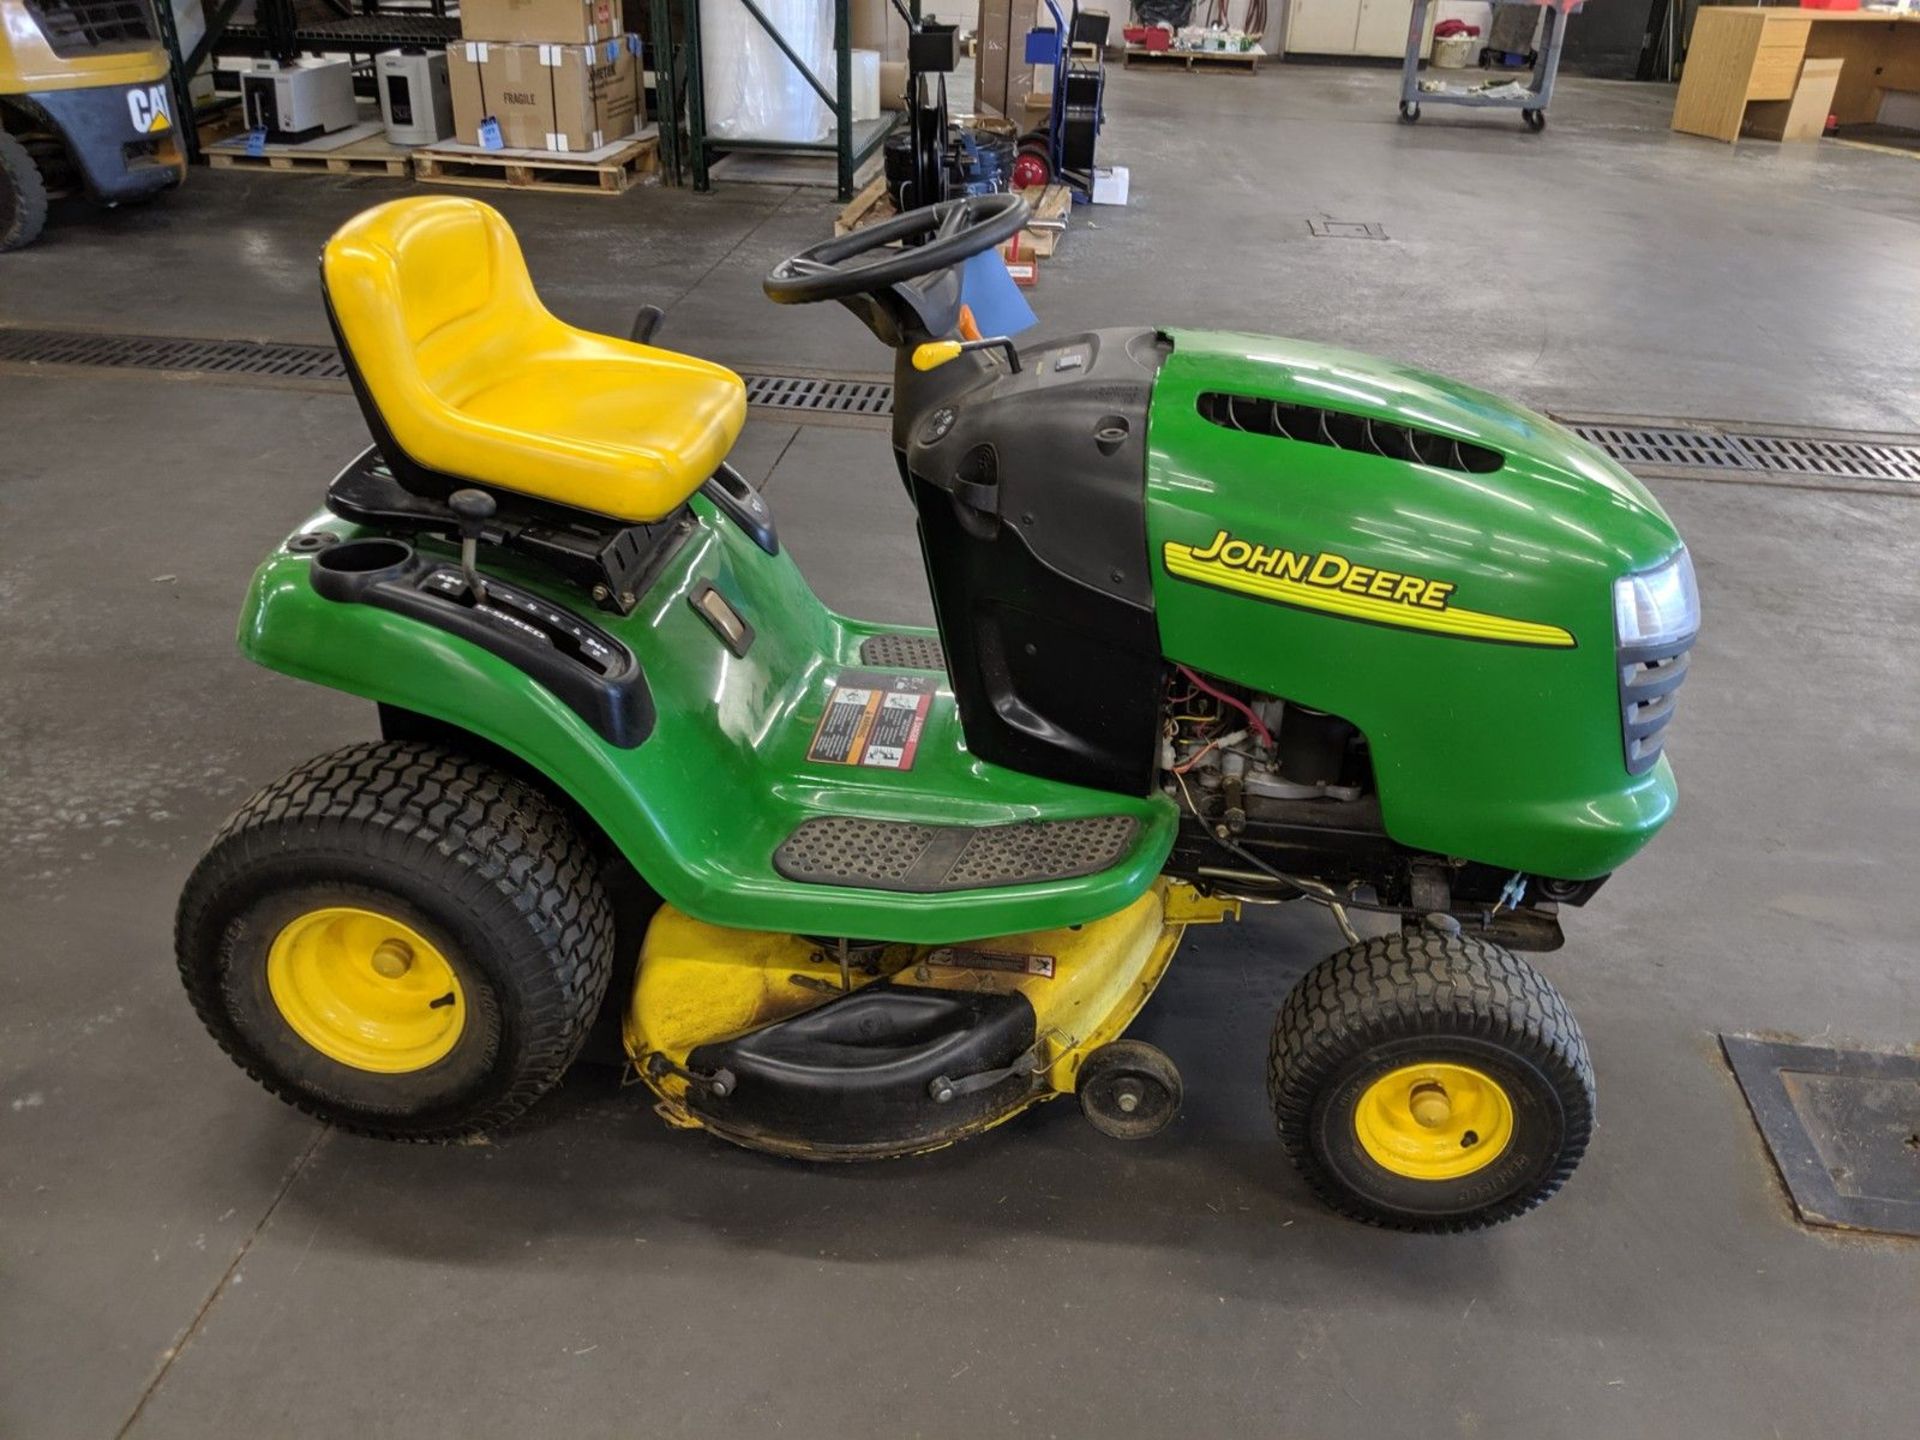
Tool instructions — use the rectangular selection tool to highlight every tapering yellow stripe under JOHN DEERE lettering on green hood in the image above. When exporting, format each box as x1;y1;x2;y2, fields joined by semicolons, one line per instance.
1162;536;1574;649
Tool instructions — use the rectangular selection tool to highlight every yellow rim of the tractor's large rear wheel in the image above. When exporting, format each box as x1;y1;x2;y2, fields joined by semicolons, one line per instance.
267;904;467;1075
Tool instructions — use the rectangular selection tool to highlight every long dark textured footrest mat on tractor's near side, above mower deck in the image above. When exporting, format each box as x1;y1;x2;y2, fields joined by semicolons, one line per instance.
774;814;1140;895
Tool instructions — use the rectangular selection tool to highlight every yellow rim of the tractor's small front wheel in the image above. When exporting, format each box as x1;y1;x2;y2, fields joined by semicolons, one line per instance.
1354;1062;1513;1181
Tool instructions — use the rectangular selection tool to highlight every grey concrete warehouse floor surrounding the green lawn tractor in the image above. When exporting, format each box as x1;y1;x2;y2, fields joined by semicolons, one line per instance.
0;67;1920;1440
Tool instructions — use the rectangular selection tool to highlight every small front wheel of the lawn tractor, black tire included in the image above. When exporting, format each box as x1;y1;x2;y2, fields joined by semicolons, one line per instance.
1267;931;1594;1231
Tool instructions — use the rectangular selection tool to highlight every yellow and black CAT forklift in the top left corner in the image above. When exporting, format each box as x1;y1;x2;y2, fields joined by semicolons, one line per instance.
0;0;192;250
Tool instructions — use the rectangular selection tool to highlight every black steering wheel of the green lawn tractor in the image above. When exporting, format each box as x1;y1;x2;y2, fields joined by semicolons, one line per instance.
760;194;1027;305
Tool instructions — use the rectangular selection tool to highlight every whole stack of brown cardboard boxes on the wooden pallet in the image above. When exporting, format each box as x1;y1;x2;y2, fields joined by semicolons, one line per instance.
447;0;645;154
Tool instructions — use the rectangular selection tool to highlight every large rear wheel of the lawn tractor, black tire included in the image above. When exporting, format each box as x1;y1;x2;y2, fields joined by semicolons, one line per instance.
175;741;612;1140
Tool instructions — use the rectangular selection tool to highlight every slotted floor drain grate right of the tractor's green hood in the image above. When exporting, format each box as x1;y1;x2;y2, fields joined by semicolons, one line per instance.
1569;424;1920;484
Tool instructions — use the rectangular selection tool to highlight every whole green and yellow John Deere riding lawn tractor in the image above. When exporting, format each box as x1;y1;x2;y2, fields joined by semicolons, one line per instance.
177;194;1699;1231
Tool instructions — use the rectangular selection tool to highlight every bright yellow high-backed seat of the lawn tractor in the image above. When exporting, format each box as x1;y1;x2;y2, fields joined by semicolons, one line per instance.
321;196;747;522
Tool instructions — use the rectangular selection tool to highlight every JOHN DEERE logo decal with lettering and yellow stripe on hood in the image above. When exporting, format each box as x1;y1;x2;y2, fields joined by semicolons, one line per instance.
1164;530;1574;649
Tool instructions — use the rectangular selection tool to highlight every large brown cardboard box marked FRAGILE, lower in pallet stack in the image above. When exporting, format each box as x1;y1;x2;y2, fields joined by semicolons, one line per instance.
447;35;641;154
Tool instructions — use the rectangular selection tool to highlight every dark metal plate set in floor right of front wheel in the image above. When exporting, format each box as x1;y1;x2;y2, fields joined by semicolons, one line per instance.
1720;1035;1920;1236
